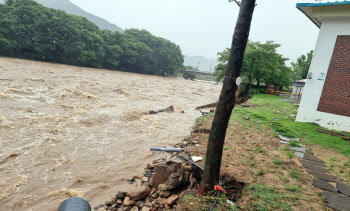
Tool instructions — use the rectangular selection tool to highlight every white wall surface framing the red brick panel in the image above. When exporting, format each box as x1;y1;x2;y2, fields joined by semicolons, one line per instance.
296;18;350;132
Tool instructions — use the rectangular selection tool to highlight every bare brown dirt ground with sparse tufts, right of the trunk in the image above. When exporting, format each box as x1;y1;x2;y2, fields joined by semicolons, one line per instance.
190;106;350;210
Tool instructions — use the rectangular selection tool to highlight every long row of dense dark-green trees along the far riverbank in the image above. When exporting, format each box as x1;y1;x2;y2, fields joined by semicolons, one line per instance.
0;0;183;76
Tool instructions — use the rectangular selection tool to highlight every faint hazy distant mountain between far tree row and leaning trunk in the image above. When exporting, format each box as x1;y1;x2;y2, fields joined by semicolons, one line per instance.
184;54;218;73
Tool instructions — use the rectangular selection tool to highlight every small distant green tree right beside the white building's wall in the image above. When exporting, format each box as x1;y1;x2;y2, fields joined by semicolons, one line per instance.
292;51;314;81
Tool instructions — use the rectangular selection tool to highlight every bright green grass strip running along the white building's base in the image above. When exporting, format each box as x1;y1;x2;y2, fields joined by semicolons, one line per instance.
231;94;350;157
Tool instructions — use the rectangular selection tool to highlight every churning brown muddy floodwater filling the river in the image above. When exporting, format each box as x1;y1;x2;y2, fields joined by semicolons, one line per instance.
0;57;221;211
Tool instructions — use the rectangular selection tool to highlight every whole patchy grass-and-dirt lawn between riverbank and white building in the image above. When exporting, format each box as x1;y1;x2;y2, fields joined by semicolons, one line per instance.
182;94;350;211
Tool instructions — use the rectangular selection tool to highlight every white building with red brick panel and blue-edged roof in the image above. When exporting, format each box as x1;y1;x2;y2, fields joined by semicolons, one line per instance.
296;1;350;132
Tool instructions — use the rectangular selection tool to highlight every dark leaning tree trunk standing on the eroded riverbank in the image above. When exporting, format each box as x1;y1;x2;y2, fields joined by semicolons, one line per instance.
199;0;256;195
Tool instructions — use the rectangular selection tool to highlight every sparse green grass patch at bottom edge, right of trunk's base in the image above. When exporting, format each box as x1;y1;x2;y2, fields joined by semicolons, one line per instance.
247;184;292;210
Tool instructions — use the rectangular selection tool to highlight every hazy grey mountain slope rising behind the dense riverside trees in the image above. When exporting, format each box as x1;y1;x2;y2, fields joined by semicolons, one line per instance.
0;0;123;32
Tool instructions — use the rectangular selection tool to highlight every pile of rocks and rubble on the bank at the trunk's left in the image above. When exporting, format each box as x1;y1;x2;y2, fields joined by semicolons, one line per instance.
101;152;200;211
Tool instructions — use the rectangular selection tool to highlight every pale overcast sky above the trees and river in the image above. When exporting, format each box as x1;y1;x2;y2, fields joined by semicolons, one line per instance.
71;0;319;61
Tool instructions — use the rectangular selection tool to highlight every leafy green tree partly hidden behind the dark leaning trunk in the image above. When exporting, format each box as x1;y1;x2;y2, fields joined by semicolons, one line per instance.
214;41;292;89
